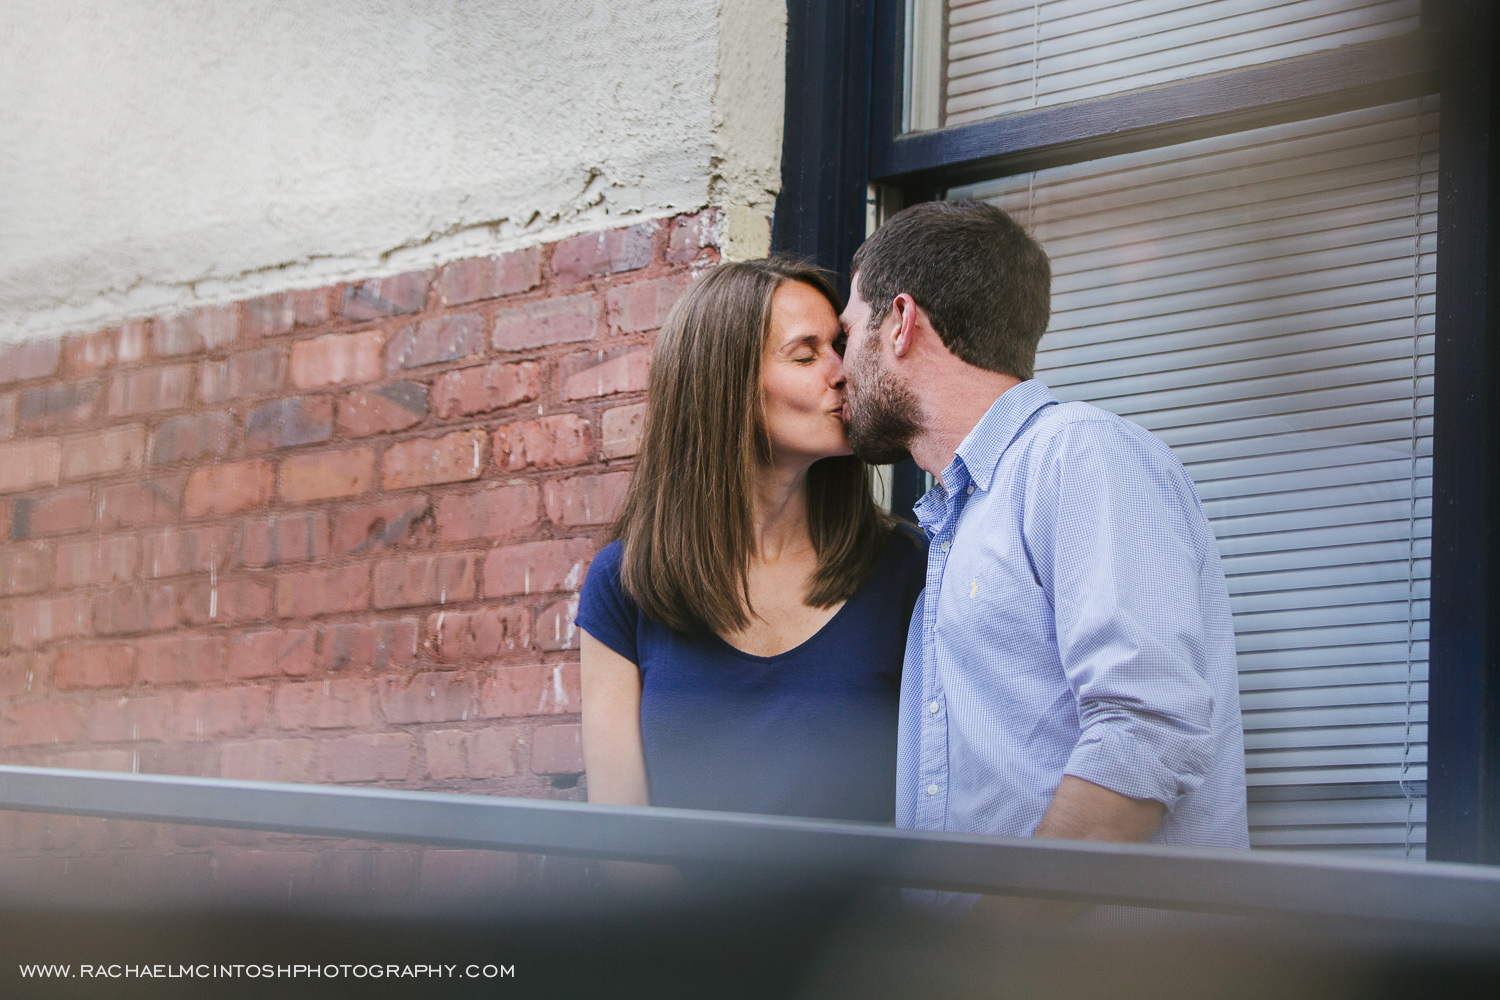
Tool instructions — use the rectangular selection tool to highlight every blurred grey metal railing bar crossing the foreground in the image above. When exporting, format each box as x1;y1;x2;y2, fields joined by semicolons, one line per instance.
0;766;1500;930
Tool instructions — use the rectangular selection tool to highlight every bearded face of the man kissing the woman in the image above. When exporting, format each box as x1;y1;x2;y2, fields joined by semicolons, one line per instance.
839;274;921;465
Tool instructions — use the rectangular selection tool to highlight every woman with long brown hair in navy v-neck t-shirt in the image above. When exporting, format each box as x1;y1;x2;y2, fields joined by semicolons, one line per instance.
578;259;926;822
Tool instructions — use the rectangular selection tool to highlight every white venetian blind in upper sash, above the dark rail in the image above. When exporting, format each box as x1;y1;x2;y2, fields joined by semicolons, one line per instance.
942;0;1422;127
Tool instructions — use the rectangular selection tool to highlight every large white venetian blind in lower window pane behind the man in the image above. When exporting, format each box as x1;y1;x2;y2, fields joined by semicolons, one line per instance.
950;99;1437;858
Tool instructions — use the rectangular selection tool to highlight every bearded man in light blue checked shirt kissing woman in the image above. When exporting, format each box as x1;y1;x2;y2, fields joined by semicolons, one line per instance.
842;202;1248;847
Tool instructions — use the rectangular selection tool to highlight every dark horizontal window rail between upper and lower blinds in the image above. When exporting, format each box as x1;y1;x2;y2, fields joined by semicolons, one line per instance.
870;31;1439;187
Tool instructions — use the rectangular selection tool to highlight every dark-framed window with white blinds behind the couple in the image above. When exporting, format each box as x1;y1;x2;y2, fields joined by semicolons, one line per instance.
776;0;1500;861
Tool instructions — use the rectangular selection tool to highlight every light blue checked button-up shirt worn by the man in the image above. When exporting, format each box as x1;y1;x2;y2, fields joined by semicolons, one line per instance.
896;381;1250;847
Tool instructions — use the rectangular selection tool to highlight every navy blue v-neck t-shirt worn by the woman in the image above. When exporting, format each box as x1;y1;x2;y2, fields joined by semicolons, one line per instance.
578;528;927;822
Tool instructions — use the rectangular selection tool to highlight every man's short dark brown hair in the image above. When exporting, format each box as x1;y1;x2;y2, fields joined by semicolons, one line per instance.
854;201;1052;379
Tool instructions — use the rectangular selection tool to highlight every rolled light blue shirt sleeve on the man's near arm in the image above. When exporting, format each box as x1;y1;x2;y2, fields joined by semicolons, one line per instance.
1023;420;1215;810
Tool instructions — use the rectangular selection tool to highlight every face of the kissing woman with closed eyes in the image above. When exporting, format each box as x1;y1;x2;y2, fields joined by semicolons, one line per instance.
761;282;851;465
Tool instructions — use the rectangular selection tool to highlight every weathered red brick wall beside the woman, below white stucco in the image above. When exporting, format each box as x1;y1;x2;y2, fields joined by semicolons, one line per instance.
0;216;717;815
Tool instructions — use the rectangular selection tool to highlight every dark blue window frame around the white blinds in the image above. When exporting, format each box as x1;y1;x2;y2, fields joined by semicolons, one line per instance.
773;0;1500;864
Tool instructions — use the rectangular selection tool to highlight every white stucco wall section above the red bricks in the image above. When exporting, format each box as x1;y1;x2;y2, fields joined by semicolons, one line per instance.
0;0;786;340
